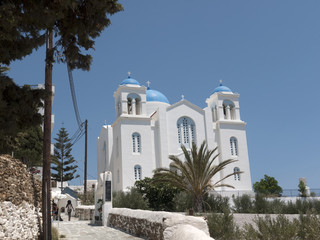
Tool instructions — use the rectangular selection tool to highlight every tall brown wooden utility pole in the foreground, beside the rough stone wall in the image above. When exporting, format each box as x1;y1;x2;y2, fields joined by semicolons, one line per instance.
42;30;53;240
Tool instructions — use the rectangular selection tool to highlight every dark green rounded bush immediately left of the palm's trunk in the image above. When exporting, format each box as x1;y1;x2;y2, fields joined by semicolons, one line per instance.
135;178;179;211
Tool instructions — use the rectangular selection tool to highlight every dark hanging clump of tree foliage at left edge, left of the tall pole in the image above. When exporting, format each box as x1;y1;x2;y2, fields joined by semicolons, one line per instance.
0;74;44;154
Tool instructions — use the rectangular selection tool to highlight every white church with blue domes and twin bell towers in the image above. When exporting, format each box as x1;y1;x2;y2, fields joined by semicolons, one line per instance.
97;76;252;195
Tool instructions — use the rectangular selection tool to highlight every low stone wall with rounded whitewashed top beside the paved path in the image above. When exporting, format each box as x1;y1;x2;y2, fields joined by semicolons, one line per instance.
108;208;212;240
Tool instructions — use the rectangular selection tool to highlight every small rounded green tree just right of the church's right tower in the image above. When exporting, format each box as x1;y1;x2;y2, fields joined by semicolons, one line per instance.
253;175;282;196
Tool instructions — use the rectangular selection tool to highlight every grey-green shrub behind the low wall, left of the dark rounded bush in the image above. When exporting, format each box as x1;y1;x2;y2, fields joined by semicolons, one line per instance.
112;188;149;210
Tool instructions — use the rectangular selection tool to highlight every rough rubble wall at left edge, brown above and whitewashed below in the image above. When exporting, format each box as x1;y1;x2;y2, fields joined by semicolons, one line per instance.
0;155;41;239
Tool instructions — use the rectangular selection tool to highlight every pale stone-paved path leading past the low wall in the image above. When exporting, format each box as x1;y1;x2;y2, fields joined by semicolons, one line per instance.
52;218;141;240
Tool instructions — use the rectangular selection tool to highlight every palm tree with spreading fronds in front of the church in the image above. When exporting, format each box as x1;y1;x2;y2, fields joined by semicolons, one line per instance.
154;141;241;212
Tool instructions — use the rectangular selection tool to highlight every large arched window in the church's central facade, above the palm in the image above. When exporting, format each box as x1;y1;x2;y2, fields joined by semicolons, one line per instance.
177;117;196;148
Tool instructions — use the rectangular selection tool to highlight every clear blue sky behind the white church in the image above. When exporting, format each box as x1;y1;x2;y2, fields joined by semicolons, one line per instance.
8;0;320;189
